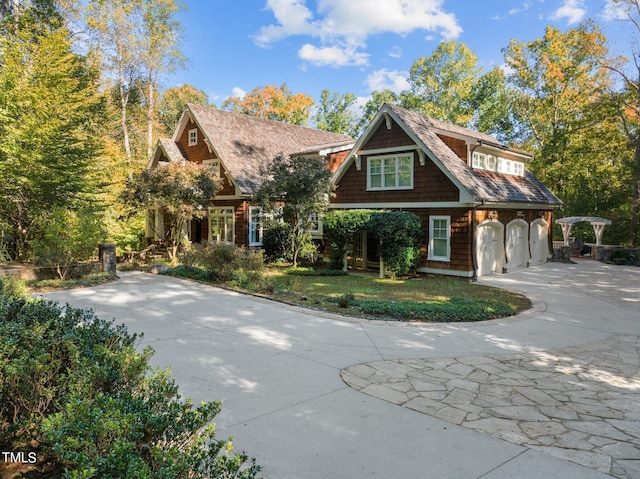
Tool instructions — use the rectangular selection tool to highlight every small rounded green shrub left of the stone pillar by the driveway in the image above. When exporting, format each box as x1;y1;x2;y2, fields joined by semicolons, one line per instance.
31;208;103;281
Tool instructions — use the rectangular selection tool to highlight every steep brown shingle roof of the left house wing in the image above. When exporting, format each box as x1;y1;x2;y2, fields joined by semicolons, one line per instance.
181;103;355;194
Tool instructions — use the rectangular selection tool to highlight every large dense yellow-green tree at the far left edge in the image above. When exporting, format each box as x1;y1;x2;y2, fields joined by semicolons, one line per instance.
0;1;102;260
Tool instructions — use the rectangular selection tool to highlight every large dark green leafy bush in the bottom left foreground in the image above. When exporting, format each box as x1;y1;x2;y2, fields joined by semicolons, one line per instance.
0;296;259;479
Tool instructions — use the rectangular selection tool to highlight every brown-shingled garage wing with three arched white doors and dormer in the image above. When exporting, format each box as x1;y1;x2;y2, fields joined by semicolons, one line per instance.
331;104;562;278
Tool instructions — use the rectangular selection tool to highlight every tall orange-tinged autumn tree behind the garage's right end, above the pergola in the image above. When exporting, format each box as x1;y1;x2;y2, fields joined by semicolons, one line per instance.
505;23;624;240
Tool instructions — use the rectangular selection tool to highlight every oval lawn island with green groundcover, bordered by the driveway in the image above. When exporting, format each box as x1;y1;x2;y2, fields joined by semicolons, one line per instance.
268;267;531;322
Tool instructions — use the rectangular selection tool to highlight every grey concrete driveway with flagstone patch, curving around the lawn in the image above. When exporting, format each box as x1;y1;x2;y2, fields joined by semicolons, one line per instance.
44;261;640;479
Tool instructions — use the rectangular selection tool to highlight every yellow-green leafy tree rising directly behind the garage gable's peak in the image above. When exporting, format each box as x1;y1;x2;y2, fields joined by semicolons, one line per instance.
403;40;481;126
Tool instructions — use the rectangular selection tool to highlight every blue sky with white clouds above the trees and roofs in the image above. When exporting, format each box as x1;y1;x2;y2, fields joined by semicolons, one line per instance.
162;0;633;107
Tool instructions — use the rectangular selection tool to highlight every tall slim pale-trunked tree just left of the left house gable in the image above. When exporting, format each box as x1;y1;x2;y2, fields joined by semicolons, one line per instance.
141;0;185;158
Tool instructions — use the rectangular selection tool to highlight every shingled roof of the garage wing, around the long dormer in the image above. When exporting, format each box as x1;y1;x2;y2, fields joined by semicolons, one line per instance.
336;104;562;206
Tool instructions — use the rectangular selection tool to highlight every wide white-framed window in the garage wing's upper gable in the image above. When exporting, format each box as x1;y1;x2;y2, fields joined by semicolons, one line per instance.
367;153;413;190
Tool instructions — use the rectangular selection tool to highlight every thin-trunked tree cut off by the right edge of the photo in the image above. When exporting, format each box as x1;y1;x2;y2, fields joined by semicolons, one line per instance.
604;0;640;246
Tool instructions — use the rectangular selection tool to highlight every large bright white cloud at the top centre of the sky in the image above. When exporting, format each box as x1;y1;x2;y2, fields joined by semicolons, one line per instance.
254;0;462;66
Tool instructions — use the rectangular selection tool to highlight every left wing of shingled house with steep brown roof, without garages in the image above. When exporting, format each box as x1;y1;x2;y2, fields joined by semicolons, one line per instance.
146;104;355;247
